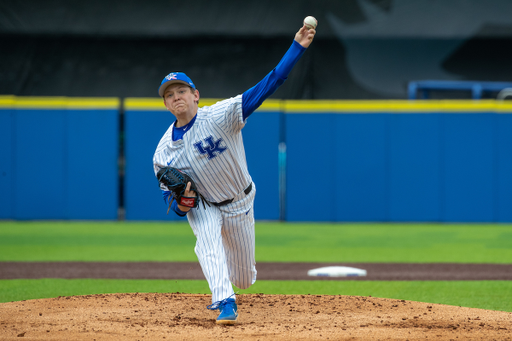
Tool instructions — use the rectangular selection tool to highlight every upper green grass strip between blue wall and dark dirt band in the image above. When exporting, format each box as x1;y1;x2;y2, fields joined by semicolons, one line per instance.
0;221;512;264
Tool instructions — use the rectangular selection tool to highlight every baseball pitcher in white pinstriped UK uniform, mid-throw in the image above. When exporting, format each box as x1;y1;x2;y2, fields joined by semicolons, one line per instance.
153;19;316;324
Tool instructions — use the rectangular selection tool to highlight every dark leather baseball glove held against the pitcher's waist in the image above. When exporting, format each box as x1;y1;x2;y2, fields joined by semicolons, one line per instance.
156;167;210;214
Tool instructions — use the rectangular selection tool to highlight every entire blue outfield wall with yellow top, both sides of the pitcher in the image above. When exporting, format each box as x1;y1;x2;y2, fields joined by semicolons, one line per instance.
0;96;512;222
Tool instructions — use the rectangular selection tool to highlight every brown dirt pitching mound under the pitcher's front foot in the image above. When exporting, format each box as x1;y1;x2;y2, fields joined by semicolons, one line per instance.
0;293;512;340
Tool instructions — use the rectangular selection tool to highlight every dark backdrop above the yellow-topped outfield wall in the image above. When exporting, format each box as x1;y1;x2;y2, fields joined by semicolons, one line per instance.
0;0;512;99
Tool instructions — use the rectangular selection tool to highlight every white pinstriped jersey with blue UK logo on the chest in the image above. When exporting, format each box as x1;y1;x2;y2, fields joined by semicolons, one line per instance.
153;95;252;202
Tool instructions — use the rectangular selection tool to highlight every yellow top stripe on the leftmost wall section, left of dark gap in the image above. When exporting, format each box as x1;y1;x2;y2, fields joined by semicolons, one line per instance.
0;96;121;110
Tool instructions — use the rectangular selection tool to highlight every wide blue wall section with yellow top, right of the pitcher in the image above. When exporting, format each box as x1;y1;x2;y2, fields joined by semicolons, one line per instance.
286;101;512;222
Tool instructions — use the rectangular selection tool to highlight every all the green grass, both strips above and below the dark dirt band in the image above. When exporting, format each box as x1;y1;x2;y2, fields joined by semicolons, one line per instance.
0;221;512;311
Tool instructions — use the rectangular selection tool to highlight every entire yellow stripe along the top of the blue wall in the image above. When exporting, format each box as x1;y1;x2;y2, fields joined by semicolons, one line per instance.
0;95;512;114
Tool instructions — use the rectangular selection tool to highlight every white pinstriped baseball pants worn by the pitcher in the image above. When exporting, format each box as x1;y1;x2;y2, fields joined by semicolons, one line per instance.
187;183;256;303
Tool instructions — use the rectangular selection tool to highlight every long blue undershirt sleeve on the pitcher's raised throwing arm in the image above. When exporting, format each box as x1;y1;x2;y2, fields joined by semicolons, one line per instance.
242;40;306;120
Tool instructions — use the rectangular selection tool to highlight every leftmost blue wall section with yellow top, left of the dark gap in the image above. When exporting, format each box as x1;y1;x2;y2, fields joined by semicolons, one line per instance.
0;96;119;220
